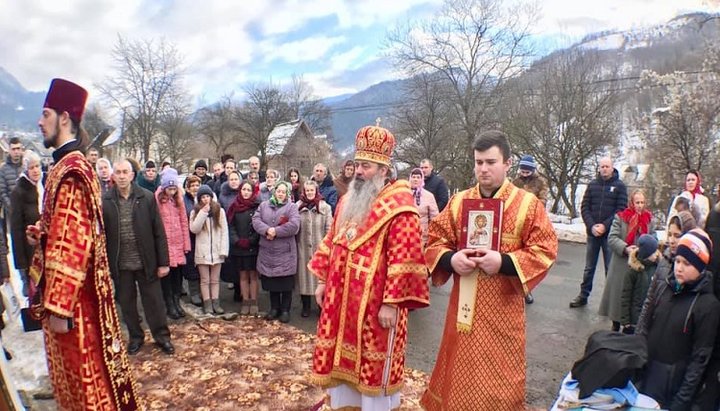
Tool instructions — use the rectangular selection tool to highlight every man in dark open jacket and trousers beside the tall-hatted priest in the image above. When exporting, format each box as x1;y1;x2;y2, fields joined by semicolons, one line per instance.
103;160;175;355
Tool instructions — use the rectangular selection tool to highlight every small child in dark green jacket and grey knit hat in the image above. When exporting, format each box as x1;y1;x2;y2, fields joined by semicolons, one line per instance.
620;234;660;334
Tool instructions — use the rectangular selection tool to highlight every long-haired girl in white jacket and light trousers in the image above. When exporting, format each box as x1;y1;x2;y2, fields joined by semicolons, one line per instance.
190;184;230;314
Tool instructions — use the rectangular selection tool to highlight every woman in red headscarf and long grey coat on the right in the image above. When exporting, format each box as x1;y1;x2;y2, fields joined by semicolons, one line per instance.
599;190;655;331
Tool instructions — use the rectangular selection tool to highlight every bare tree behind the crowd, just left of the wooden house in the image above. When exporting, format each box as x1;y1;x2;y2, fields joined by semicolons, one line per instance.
235;84;295;166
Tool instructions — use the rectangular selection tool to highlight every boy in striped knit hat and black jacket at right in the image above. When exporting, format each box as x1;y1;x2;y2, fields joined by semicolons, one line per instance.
640;228;720;410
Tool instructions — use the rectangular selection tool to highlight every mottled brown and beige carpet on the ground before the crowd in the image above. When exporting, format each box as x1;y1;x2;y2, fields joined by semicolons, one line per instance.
131;317;428;411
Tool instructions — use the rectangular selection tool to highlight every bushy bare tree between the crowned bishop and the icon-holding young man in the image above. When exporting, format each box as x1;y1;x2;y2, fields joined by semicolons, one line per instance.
390;73;458;177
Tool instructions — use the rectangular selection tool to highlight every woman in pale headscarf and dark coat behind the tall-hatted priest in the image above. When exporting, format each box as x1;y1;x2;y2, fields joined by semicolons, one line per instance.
9;150;44;297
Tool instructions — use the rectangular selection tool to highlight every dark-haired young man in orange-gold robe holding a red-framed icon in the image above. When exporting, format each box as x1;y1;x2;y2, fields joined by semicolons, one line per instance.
421;131;558;411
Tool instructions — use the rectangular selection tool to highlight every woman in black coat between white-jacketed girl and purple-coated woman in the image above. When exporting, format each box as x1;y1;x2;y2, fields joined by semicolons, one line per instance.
227;181;260;316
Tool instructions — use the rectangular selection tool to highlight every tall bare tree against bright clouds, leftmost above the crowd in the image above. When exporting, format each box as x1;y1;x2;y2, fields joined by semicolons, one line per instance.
97;36;184;161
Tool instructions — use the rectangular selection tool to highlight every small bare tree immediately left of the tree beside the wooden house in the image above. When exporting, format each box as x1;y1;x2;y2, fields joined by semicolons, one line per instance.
195;94;241;158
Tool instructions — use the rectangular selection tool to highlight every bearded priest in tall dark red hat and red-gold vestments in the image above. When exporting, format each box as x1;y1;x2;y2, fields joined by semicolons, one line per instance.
26;79;142;410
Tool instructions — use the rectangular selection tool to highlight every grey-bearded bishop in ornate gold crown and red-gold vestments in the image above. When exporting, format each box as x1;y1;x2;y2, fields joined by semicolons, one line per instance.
308;126;429;410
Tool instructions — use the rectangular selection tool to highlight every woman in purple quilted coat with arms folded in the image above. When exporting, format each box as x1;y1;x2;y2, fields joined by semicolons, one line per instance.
252;181;300;323
